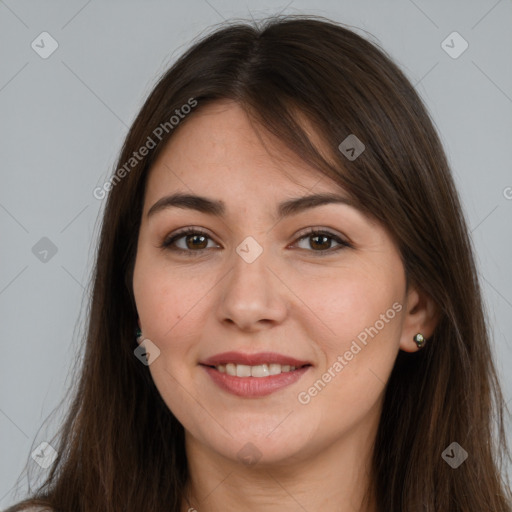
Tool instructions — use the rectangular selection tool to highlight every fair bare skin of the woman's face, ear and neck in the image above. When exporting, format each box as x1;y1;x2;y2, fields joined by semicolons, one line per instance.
133;101;435;512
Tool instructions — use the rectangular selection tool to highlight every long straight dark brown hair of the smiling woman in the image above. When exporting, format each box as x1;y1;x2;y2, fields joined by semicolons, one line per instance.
8;16;511;512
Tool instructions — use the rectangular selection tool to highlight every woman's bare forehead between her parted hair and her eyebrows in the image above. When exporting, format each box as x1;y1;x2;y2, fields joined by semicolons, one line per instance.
145;101;343;211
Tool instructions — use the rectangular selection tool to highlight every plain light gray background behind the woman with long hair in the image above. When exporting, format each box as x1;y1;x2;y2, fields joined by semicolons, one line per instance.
0;0;512;508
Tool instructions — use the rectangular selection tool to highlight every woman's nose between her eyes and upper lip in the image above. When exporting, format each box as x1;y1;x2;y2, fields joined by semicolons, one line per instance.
217;243;290;332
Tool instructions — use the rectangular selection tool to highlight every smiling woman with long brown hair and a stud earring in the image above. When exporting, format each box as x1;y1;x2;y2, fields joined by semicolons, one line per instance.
8;16;511;512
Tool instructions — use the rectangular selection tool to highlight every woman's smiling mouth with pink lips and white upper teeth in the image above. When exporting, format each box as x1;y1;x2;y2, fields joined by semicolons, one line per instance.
199;352;313;398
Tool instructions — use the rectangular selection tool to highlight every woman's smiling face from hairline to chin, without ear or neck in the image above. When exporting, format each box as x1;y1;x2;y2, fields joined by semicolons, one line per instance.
133;102;410;464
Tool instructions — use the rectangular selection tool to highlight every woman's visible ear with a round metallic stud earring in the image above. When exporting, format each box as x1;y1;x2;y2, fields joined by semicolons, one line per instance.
400;285;439;352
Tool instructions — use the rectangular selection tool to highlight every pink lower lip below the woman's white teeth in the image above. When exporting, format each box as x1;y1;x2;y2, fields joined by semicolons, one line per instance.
201;365;311;397
